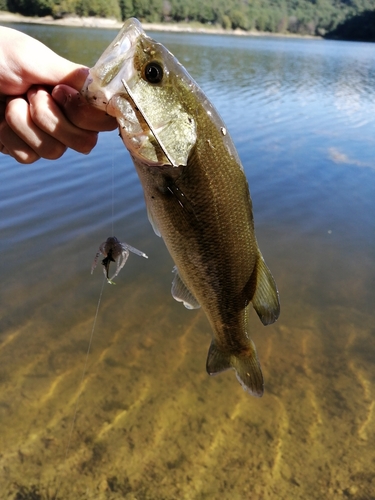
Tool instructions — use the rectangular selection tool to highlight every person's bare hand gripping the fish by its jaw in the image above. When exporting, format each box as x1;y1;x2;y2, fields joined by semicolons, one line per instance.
0;27;117;164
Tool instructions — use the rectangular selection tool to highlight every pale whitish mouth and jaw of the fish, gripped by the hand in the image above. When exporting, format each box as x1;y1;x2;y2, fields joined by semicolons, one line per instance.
81;18;147;114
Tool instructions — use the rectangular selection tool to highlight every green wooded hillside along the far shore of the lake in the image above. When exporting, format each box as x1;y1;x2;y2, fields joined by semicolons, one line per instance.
4;0;375;38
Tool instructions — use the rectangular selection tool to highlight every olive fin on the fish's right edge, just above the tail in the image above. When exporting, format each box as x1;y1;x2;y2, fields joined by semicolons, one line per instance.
252;254;280;325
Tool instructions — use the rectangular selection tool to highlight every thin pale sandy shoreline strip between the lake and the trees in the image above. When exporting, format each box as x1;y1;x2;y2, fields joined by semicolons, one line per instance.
0;11;322;40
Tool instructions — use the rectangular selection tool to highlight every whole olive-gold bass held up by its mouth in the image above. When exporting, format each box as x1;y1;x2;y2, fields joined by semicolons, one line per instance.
81;18;280;397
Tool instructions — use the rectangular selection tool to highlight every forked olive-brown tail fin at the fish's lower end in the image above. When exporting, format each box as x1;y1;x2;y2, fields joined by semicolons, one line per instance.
206;340;264;397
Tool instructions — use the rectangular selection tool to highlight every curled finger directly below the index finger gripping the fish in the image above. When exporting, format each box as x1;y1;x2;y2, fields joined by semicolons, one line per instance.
27;87;98;154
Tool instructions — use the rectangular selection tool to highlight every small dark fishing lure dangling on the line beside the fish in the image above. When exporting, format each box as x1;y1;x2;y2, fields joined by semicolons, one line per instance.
91;236;148;285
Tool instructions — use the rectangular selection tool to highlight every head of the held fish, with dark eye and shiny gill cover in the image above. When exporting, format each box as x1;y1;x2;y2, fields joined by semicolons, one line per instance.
82;18;199;167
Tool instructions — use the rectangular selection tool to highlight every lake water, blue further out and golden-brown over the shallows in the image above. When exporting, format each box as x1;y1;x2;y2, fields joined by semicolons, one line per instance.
0;25;375;500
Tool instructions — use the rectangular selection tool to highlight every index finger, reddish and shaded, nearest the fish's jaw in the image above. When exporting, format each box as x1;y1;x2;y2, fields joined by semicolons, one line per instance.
52;84;117;132
